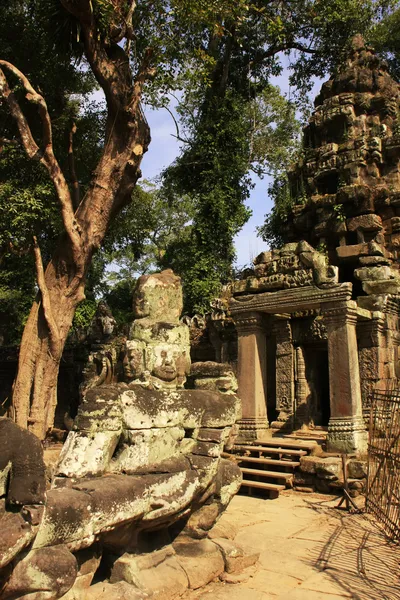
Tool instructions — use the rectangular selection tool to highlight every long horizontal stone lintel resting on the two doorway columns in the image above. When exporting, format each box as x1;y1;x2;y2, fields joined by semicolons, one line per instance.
229;283;353;322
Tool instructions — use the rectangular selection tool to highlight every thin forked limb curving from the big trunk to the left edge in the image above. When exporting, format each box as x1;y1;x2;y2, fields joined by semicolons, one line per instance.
0;60;81;256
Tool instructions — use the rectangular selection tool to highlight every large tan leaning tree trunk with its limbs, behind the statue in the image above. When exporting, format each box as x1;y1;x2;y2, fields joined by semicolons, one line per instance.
5;0;153;439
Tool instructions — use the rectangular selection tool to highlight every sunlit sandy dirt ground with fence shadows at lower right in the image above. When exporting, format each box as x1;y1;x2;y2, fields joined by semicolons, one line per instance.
185;490;400;600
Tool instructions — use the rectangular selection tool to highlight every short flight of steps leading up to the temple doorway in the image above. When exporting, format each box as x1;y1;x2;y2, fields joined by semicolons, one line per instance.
223;437;318;498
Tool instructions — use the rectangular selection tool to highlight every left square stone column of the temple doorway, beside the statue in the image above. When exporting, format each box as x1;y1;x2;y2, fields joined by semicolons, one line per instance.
234;313;268;440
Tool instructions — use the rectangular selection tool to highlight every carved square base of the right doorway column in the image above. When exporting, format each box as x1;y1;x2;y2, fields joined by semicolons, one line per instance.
326;417;368;454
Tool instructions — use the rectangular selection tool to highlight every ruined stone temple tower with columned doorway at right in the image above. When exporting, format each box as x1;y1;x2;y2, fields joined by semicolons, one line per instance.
230;36;400;452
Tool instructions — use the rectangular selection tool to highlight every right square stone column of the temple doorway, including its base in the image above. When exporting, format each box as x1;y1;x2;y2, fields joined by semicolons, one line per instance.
323;300;367;452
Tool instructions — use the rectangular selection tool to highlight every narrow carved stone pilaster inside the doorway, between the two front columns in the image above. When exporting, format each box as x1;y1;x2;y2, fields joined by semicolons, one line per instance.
273;314;294;428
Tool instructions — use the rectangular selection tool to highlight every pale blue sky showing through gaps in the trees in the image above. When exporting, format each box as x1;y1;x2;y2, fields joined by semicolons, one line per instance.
142;65;321;266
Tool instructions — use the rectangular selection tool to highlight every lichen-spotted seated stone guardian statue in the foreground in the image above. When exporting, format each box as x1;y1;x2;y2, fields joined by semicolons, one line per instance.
1;270;241;600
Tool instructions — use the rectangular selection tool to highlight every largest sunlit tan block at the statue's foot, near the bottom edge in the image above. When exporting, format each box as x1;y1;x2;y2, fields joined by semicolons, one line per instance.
110;546;188;599
